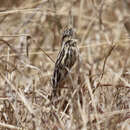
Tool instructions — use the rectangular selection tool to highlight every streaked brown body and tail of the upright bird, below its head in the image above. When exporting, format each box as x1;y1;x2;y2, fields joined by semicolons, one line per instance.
52;39;78;96
